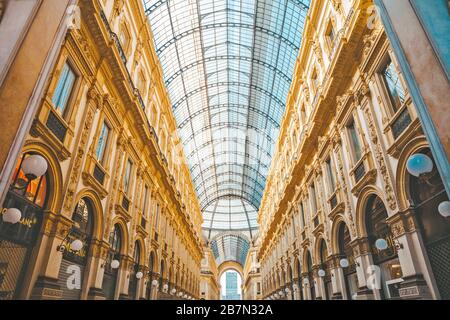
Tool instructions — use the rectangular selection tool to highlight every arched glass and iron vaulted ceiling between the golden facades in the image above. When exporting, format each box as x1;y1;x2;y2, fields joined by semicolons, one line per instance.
144;0;309;240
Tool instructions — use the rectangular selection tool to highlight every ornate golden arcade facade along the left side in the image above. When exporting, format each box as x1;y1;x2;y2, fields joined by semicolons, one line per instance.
0;0;203;299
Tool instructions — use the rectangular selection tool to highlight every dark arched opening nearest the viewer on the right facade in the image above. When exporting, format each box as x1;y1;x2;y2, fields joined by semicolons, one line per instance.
406;148;450;300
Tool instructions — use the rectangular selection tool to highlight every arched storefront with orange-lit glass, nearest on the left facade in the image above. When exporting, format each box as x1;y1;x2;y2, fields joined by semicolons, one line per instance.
0;153;49;300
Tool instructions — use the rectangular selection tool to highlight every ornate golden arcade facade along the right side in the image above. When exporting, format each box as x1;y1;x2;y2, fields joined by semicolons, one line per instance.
258;1;450;300
